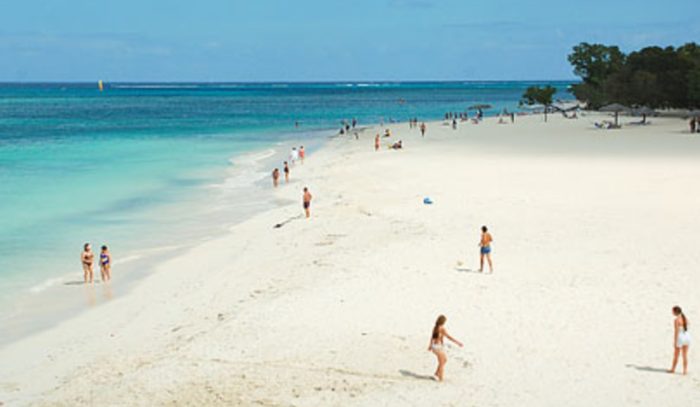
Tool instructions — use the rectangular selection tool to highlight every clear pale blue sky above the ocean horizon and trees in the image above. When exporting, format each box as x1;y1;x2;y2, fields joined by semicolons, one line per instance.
0;0;700;82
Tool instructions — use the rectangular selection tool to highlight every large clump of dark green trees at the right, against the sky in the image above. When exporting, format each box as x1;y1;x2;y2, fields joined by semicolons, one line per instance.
569;42;700;108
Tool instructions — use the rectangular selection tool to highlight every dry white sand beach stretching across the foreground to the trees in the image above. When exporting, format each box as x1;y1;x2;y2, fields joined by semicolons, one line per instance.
0;115;700;406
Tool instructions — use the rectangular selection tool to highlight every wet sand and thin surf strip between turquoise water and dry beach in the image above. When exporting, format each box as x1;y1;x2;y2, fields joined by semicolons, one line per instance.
0;129;328;349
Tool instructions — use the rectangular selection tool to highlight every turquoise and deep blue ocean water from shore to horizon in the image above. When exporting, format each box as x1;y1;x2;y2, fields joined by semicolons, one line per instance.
0;82;571;342
